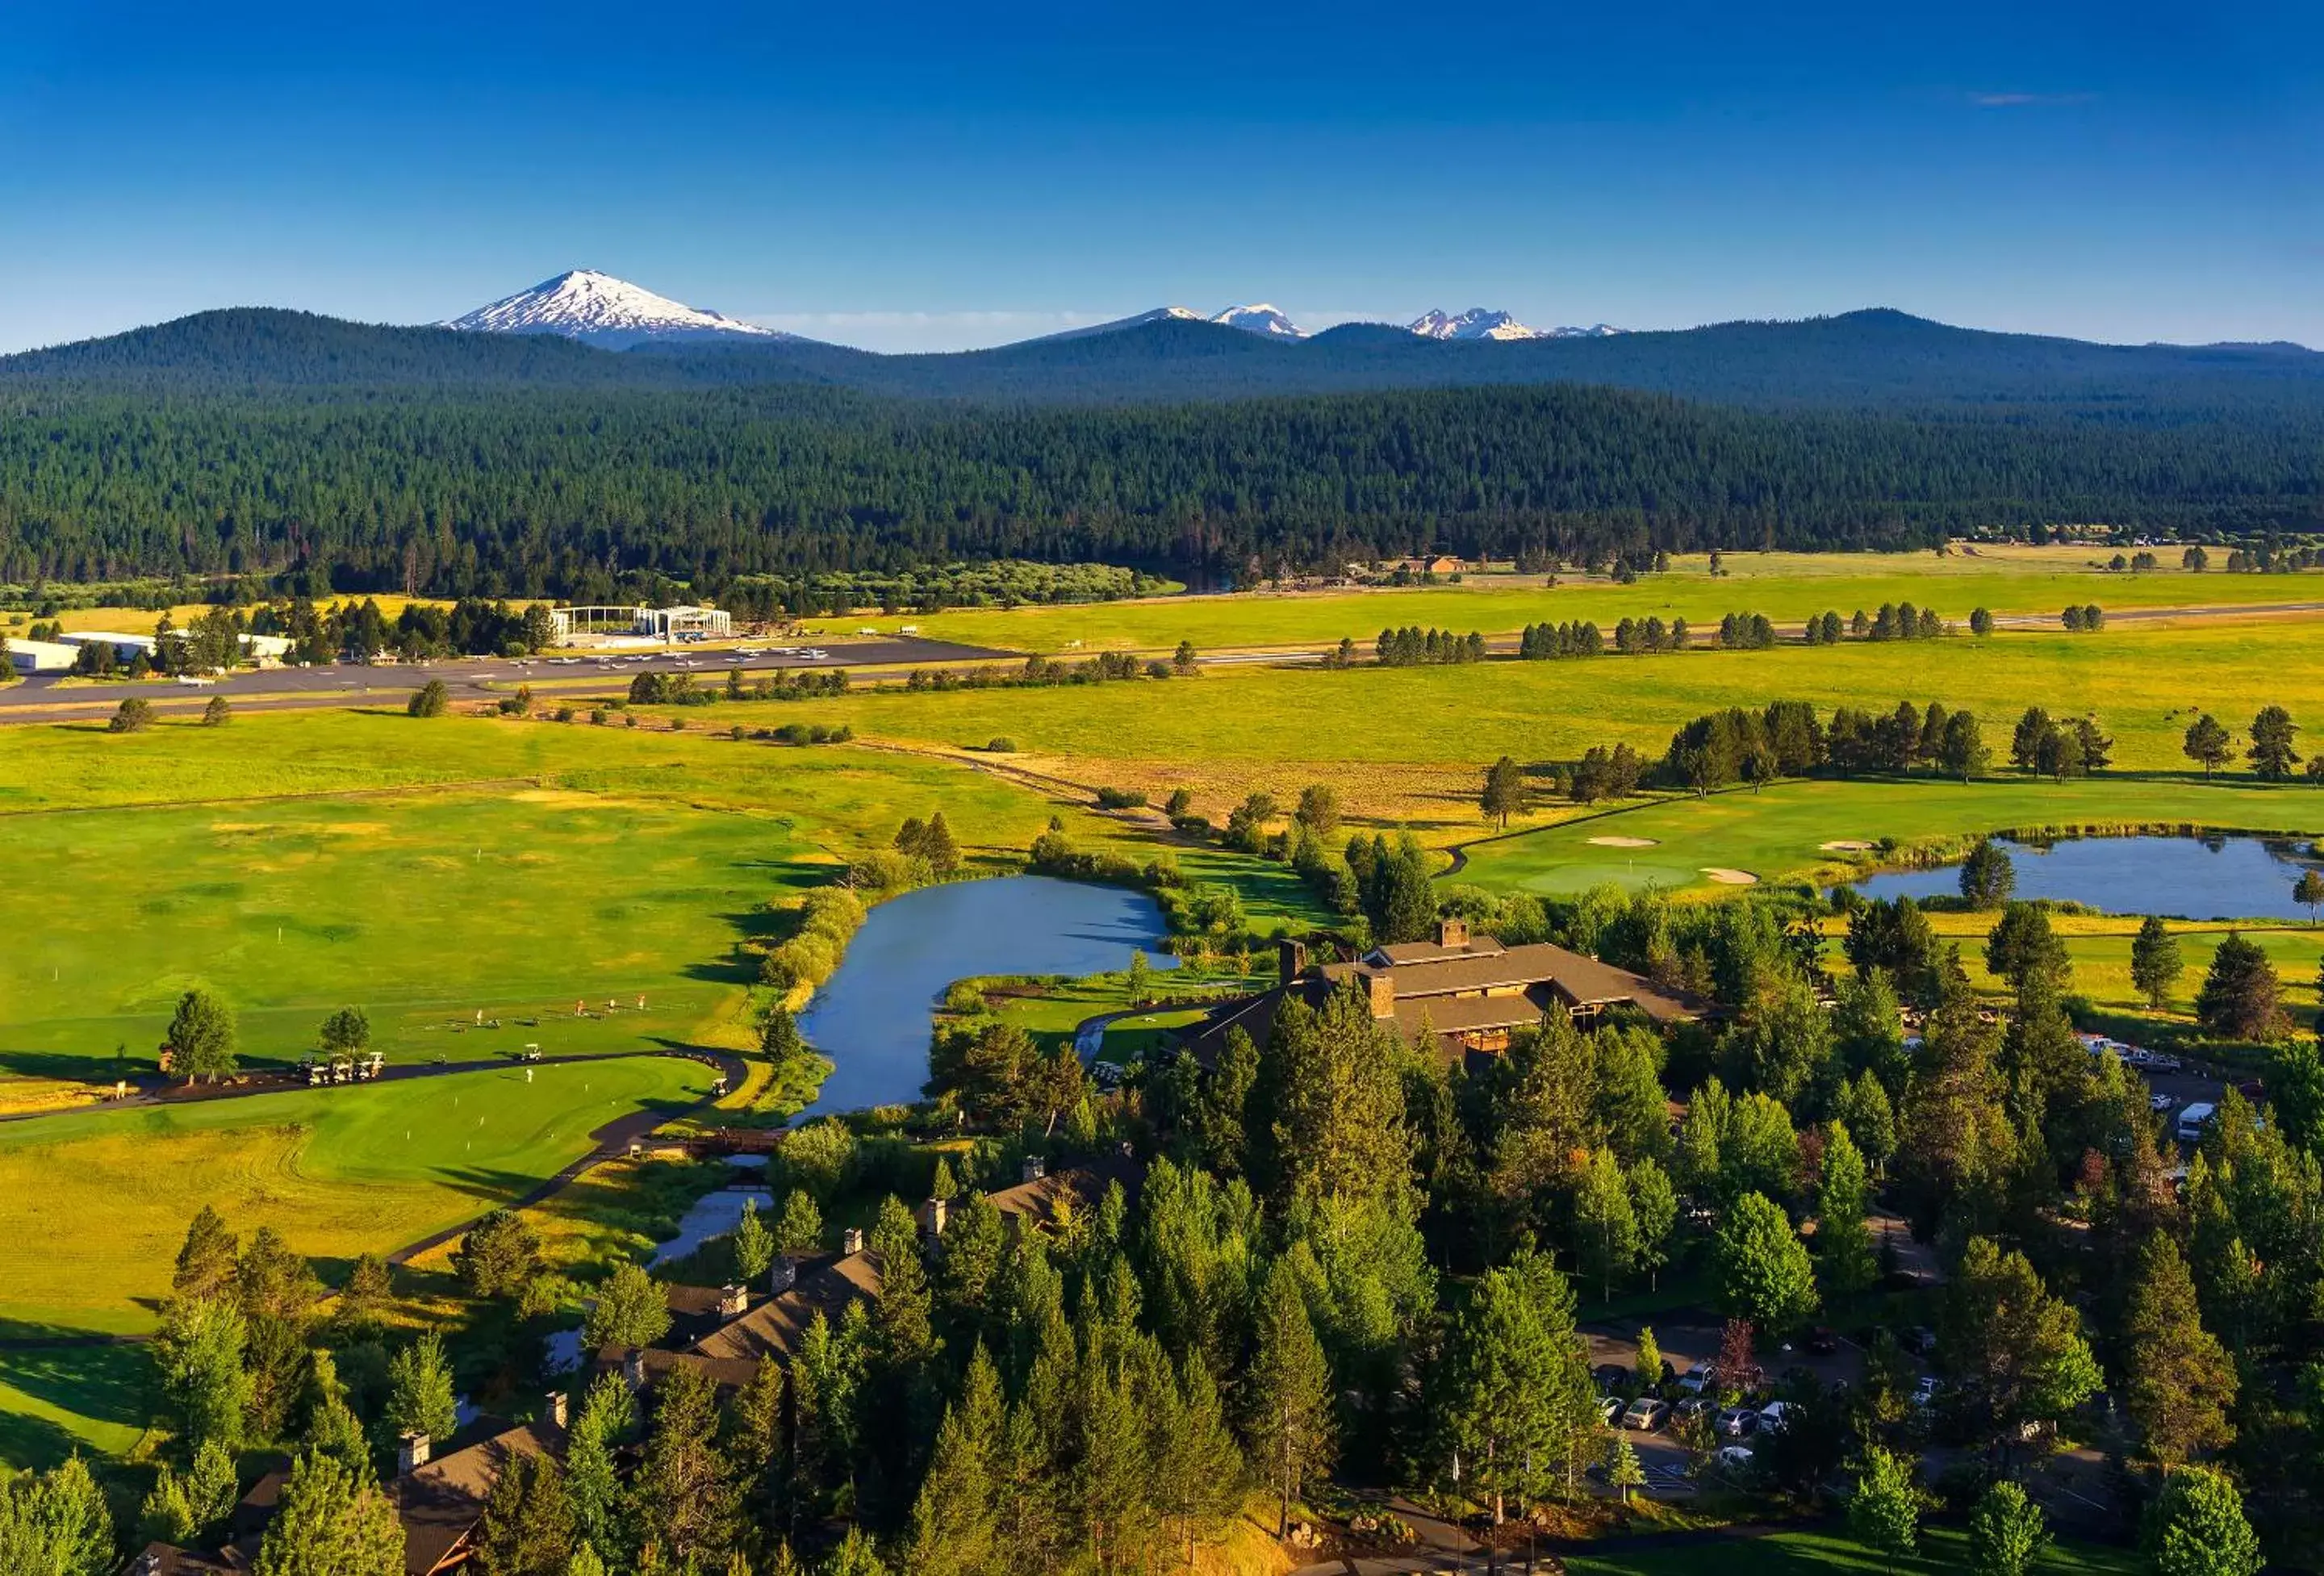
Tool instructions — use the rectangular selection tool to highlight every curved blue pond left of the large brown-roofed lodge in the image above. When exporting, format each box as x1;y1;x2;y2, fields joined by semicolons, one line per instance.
800;876;1178;1120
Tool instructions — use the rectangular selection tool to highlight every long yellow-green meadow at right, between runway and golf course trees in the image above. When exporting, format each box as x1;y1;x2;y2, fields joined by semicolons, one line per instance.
627;622;2324;867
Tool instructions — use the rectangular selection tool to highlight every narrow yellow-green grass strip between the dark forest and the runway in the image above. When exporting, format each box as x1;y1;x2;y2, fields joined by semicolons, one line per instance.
911;546;2317;653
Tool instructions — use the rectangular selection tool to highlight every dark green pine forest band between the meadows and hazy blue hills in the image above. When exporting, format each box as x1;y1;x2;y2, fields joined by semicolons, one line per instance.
0;378;2324;597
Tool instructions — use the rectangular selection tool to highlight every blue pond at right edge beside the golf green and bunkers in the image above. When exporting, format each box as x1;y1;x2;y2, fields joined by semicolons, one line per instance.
1857;837;2319;921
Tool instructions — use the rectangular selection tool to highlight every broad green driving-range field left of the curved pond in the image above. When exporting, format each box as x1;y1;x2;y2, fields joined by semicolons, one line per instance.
0;711;1189;1097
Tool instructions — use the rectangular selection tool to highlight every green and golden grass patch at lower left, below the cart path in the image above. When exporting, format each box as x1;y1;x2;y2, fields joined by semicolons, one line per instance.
0;1056;711;1334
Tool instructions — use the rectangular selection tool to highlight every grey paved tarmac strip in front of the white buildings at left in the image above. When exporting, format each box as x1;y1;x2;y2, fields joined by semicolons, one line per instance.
0;637;1016;721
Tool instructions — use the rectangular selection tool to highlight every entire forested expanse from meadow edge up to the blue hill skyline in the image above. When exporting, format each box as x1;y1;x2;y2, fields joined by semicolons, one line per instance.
0;311;2324;597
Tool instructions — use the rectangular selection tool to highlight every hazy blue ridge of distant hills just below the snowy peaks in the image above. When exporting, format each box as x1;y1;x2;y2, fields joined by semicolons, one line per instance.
0;309;2324;418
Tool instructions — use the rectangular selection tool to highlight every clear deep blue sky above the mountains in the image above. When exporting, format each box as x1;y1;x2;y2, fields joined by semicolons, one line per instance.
0;0;2324;349
